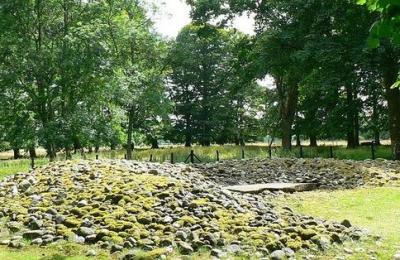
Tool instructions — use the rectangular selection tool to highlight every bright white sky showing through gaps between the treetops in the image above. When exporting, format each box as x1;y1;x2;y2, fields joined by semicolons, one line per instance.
148;0;254;38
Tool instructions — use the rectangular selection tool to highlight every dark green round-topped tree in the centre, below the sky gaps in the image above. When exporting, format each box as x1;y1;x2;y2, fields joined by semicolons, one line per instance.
169;24;229;146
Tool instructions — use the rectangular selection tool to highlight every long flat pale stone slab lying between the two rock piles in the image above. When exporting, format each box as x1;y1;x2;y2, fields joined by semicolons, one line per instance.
225;182;317;193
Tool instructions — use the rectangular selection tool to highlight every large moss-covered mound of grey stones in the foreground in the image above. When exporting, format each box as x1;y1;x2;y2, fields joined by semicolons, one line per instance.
0;160;366;259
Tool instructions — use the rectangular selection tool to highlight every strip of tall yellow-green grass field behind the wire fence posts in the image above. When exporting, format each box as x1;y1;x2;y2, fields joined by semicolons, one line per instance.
0;144;391;177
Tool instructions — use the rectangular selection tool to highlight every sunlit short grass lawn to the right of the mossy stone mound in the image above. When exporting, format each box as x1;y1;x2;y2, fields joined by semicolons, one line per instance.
279;187;400;259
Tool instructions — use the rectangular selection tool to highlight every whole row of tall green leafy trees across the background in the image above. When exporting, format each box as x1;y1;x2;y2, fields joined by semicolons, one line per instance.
0;0;400;159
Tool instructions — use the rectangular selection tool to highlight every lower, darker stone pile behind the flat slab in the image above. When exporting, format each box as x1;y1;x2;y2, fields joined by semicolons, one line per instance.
195;159;400;189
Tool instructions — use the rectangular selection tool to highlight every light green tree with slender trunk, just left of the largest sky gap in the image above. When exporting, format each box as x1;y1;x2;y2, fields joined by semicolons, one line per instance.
102;0;168;159
